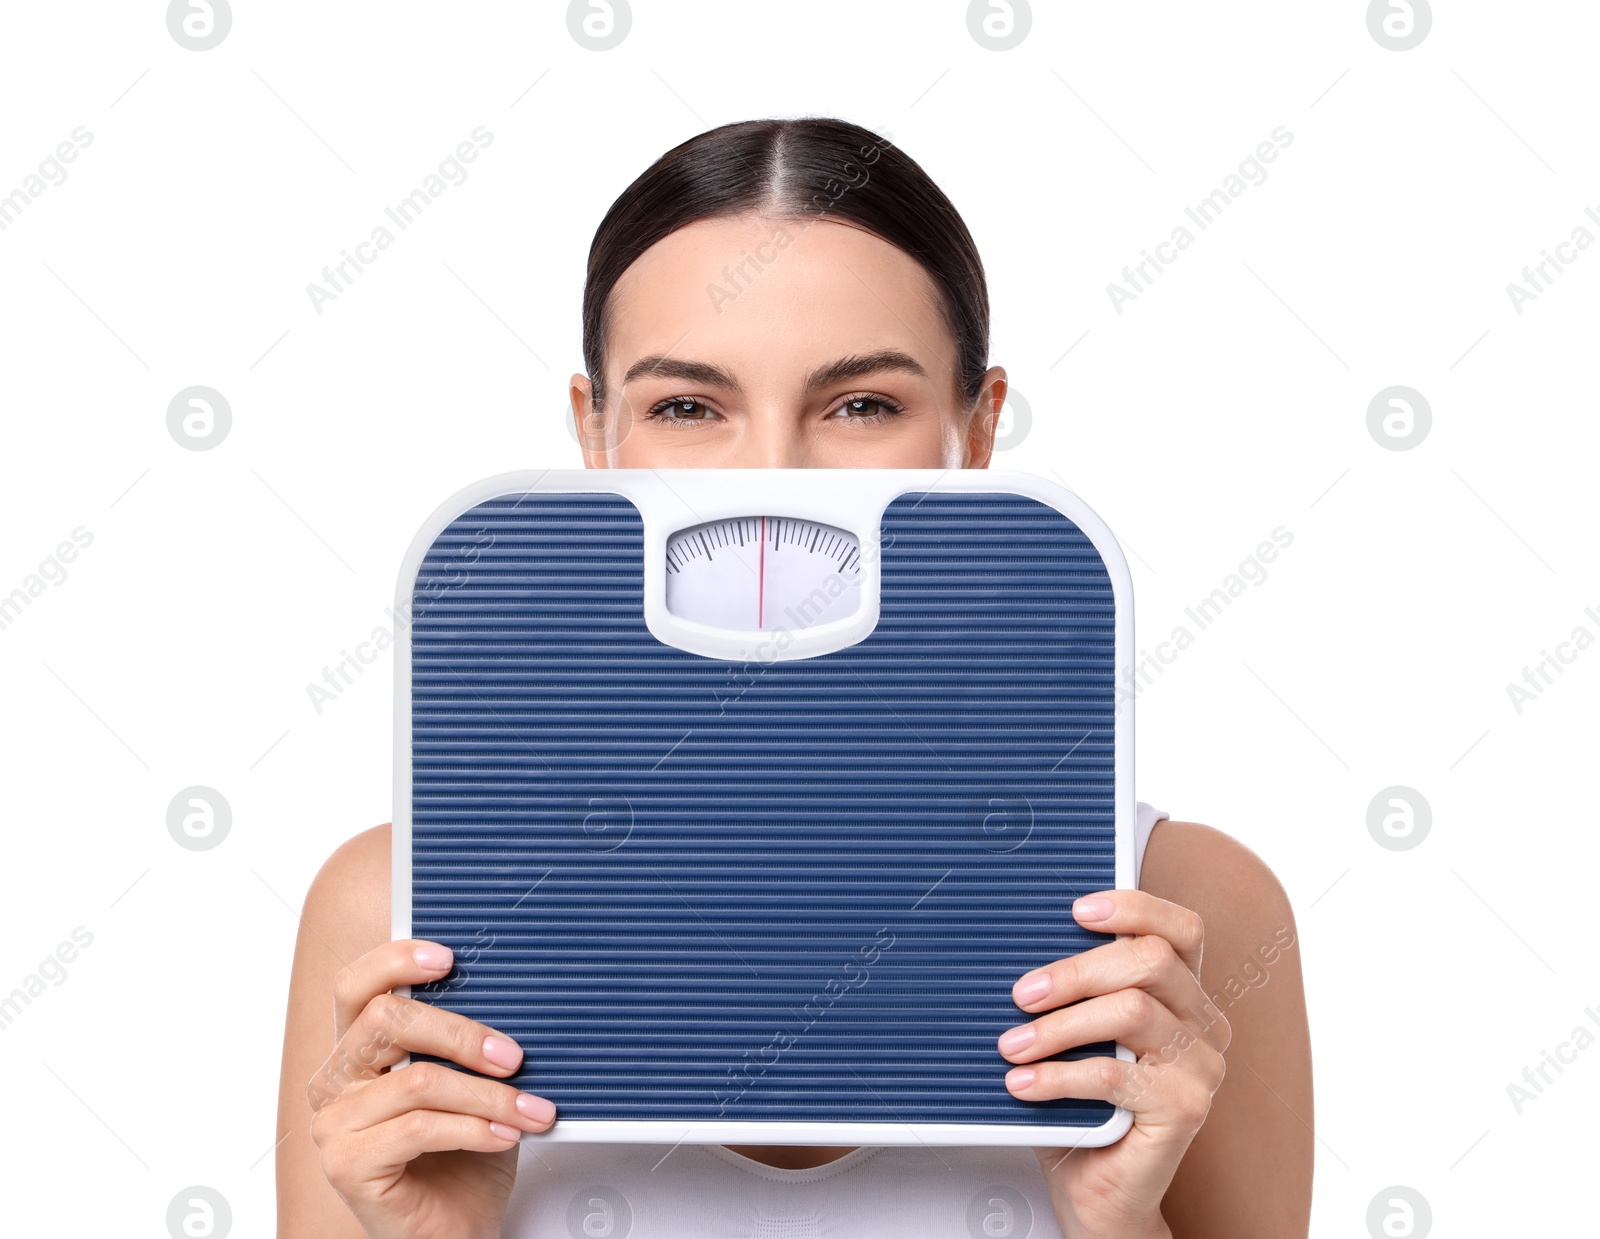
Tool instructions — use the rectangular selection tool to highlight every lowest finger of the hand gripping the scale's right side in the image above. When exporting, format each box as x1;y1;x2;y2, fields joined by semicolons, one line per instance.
1005;1042;1227;1135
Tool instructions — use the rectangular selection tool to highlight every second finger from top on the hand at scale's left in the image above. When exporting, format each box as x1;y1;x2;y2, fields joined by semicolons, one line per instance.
309;994;522;1111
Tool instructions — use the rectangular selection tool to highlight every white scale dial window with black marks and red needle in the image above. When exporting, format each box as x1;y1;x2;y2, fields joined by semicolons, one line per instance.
667;515;861;631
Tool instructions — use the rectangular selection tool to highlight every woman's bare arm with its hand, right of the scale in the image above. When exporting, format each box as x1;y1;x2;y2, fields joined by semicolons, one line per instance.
998;823;1312;1239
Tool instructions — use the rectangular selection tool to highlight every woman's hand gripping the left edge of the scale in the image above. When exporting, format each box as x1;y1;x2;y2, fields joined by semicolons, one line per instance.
307;940;555;1239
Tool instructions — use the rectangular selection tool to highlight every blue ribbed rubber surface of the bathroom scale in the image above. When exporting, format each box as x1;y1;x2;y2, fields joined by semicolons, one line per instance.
411;493;1115;1125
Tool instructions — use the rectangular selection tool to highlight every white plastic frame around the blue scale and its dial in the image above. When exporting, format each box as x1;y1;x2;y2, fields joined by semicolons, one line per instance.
390;469;1134;1148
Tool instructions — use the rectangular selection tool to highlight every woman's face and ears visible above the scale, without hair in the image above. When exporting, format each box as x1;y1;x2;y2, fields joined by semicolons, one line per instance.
571;215;1006;469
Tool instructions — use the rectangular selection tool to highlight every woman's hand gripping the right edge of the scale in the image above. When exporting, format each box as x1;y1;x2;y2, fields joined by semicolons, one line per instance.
998;890;1230;1239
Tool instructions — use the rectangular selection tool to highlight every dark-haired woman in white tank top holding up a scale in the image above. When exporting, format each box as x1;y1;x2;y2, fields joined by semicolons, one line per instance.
277;118;1312;1239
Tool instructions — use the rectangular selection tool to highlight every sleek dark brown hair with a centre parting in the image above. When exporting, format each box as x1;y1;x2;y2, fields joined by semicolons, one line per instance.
584;117;989;408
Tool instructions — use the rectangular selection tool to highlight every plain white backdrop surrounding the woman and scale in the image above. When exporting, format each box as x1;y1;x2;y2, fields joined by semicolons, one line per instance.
0;0;1600;1236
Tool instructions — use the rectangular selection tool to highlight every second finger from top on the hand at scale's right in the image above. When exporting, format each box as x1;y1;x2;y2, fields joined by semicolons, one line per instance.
1011;935;1230;1050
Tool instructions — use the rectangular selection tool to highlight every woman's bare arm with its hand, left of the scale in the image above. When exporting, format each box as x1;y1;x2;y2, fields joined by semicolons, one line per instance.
277;826;555;1239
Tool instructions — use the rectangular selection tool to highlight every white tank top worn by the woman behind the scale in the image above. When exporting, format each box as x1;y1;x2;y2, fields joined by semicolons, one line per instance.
501;800;1168;1239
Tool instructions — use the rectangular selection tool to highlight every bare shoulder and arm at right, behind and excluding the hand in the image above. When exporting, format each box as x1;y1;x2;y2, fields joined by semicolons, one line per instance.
1139;821;1315;1239
